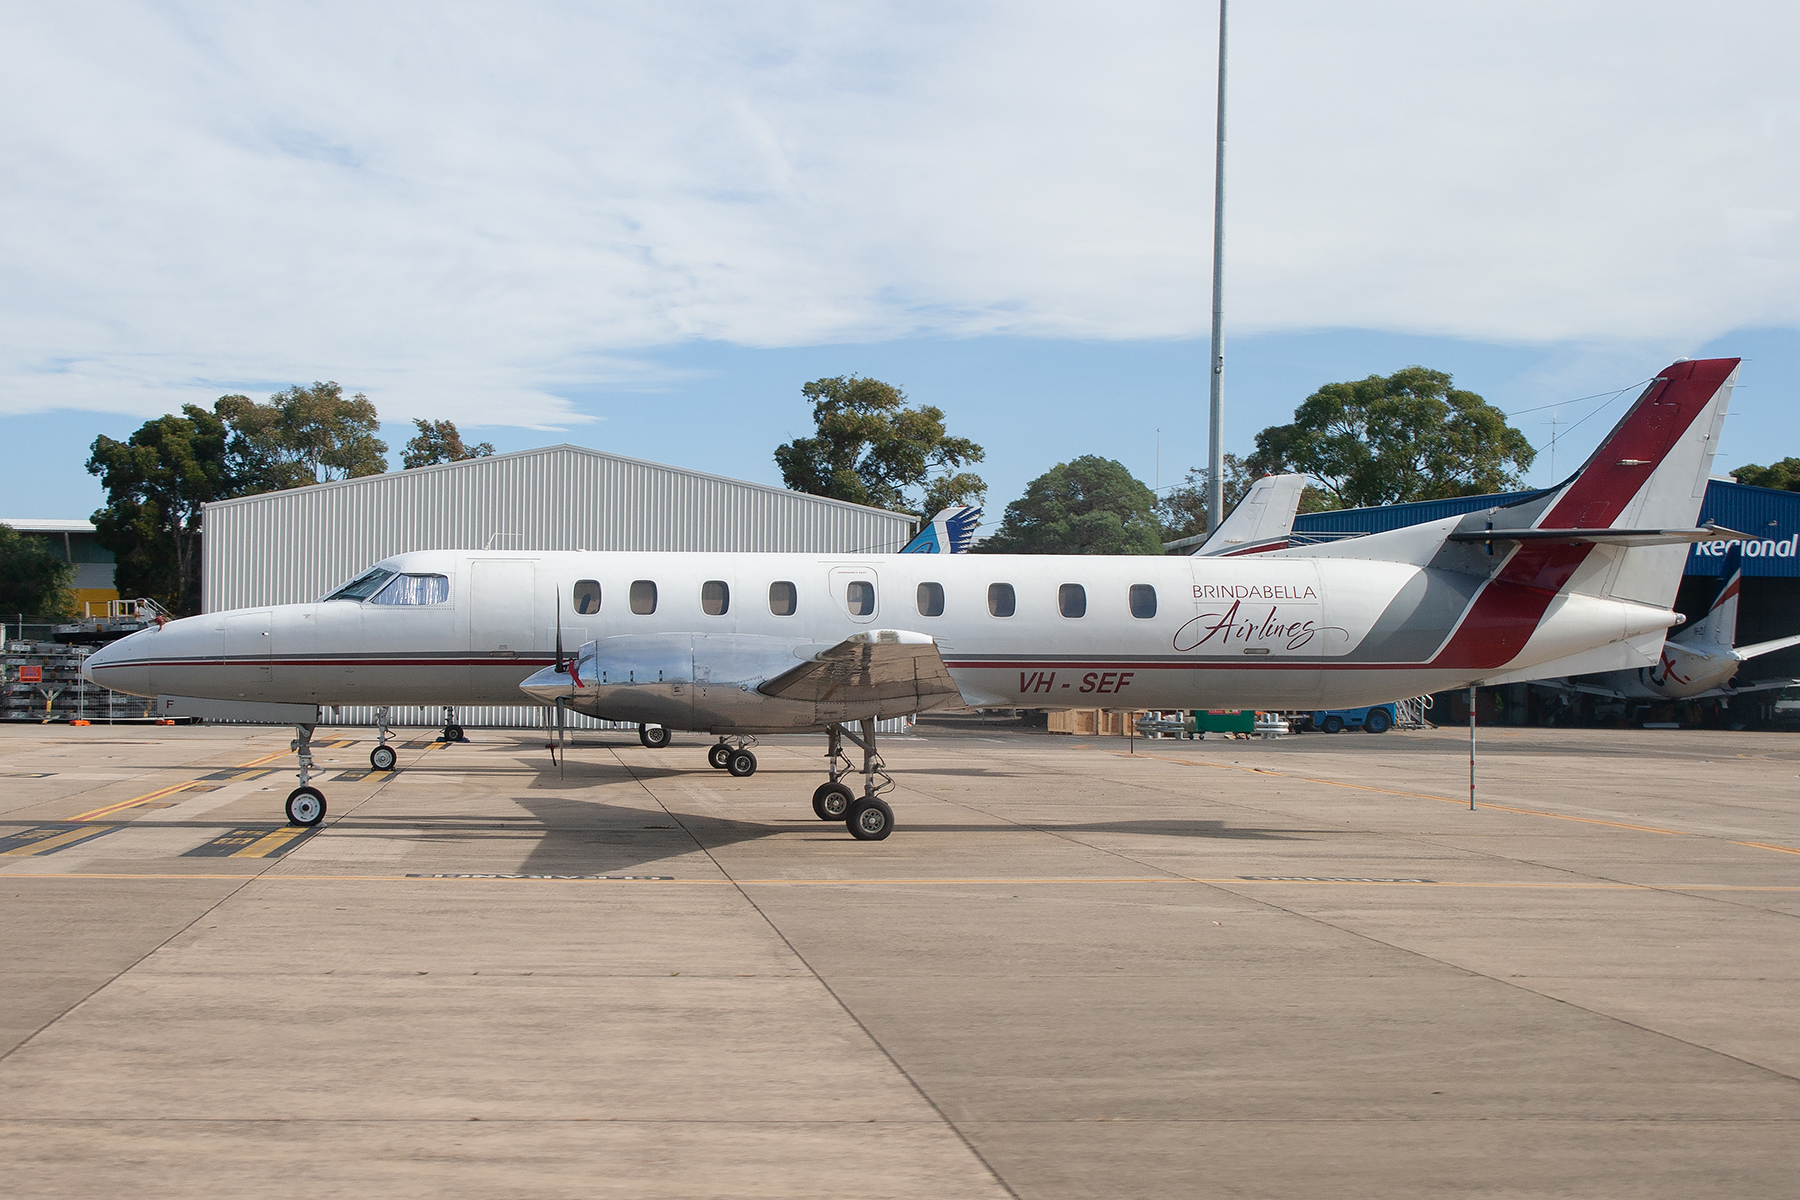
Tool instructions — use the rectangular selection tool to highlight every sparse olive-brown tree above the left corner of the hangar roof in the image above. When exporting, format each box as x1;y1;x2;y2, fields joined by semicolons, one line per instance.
212;381;387;488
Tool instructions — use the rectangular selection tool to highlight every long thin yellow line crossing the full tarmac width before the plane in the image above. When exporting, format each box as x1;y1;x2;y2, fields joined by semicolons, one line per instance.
0;871;1800;892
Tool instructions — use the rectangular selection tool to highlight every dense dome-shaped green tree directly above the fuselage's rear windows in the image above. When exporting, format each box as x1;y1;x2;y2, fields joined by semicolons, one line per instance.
976;453;1163;554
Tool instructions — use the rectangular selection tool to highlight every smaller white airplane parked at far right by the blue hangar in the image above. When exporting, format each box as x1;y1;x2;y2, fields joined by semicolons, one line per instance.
1543;545;1800;700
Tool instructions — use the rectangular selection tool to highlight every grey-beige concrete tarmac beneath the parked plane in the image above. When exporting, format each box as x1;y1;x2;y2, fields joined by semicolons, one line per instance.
0;721;1800;1198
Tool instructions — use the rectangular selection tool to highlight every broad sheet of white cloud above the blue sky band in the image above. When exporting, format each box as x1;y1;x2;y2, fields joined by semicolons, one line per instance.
0;2;1800;425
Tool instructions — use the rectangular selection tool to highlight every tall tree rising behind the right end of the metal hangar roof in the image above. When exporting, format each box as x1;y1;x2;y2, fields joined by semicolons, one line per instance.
776;374;988;516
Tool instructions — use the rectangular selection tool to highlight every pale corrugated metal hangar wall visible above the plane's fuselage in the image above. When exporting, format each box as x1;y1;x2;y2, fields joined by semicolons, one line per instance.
202;446;914;612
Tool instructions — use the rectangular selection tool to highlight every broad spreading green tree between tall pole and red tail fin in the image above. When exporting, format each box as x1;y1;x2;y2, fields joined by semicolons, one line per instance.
1249;367;1537;507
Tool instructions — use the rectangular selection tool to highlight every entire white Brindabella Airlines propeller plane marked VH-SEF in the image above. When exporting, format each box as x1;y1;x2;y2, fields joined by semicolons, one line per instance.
85;358;1742;840
